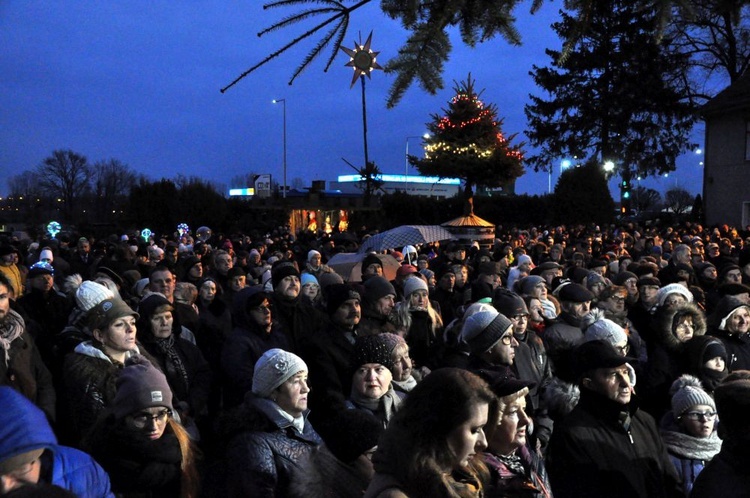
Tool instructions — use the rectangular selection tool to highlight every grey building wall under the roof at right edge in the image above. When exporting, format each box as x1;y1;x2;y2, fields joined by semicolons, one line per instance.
703;113;750;226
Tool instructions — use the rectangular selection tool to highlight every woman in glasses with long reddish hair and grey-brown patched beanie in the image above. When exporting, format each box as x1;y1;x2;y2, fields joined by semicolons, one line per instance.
84;355;199;498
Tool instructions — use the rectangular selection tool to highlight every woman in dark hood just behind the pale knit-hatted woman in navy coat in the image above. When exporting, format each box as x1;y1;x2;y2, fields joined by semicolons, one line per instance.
221;285;291;408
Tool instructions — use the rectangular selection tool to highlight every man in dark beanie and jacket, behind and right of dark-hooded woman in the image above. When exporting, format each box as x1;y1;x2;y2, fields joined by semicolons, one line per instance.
271;261;323;353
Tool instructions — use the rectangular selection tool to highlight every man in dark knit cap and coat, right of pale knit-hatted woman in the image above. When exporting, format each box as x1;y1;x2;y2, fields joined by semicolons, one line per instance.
300;284;362;423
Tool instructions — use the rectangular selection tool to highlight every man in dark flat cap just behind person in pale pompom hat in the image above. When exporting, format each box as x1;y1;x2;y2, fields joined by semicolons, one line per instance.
544;283;594;367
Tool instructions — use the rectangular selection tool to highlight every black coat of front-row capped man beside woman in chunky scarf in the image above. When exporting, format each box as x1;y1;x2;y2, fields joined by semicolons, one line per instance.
547;389;681;498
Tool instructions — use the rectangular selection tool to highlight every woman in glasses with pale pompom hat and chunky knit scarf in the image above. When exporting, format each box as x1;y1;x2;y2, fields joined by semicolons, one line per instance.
660;375;721;496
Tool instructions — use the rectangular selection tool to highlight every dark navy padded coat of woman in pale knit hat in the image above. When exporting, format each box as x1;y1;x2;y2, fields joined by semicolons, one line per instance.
220;395;321;498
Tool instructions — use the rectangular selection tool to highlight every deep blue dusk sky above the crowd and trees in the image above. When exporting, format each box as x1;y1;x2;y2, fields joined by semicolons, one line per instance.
0;0;703;200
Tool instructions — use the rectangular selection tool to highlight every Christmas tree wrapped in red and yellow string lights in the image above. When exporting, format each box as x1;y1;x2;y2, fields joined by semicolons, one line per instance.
409;74;524;211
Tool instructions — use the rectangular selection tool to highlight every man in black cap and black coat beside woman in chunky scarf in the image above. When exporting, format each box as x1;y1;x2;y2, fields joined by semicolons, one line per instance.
547;340;684;498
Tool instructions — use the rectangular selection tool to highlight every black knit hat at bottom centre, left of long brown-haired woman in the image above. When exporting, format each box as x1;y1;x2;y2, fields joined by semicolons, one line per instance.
323;410;385;463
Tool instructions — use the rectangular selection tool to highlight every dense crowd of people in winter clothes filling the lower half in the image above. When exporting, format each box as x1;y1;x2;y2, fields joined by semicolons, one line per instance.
0;223;750;498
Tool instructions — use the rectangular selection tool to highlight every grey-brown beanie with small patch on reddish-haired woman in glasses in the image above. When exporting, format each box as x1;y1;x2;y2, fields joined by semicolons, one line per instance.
112;354;173;419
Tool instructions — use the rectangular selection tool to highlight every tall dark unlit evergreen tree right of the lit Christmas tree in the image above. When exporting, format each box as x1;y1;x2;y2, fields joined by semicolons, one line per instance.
526;0;696;182
